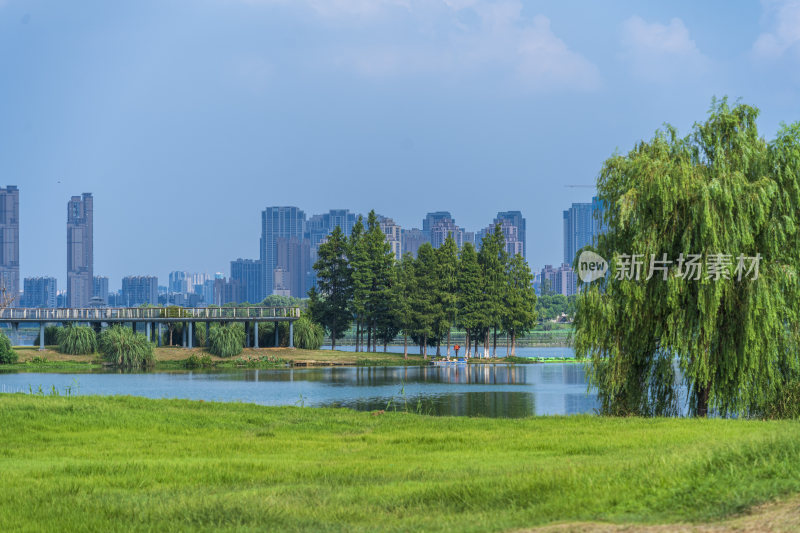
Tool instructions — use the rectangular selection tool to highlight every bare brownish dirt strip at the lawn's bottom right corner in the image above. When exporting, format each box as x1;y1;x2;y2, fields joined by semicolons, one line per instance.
519;497;800;533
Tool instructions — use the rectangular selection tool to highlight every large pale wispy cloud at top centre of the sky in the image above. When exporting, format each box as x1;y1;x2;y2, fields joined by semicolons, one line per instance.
322;0;600;91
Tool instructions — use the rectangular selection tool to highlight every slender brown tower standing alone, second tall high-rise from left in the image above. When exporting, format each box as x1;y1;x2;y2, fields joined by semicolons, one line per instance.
67;193;94;307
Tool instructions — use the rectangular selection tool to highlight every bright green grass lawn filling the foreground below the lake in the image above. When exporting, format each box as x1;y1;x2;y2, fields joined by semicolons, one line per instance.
0;395;800;531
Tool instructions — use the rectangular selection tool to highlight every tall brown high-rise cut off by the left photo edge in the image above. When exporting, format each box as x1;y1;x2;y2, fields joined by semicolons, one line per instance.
0;185;19;306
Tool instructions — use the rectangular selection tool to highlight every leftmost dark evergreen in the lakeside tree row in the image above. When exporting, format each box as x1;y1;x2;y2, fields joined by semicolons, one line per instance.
309;226;353;350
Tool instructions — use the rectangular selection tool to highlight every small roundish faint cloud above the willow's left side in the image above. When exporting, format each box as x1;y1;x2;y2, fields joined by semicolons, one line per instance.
621;16;709;82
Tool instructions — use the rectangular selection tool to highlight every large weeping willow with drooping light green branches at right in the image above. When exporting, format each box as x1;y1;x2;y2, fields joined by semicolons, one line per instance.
575;100;800;416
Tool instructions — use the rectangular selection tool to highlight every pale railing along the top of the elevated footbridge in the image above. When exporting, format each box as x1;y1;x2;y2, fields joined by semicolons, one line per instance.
0;307;300;322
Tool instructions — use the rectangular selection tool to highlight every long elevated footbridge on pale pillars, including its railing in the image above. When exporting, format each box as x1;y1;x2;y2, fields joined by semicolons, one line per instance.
0;306;300;350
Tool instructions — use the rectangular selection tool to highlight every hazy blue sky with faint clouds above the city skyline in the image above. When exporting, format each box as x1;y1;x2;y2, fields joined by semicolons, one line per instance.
0;0;800;289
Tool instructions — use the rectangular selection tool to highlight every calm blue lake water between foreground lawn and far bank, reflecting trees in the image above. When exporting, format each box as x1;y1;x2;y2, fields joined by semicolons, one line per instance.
0;363;597;418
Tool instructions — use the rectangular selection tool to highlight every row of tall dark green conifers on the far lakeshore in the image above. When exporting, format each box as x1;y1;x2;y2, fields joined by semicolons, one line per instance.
309;211;536;358
